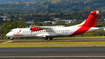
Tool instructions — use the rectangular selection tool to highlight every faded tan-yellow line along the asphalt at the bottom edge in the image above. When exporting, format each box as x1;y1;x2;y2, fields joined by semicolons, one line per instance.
0;56;105;58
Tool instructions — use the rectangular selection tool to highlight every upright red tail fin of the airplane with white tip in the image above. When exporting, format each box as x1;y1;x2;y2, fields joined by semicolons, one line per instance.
82;11;99;27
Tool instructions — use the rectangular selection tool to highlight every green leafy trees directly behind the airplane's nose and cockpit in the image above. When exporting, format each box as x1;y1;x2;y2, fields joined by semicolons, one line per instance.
0;19;26;38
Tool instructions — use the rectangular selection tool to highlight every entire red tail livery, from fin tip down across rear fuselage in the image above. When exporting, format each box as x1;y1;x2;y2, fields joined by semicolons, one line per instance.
70;11;99;36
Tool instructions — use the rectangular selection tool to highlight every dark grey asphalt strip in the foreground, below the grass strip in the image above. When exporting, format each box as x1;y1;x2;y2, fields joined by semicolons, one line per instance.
0;47;105;59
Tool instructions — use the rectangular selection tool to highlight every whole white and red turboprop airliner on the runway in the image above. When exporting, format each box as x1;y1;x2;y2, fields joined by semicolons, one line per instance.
6;11;99;40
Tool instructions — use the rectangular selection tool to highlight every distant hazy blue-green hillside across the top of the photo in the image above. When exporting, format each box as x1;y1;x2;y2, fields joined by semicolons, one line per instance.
0;0;105;12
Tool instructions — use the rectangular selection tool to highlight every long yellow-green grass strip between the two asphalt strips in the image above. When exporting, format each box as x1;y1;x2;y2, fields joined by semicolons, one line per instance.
0;42;105;47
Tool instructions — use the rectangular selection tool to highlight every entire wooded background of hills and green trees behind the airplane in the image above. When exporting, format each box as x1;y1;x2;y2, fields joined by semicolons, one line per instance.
0;0;105;38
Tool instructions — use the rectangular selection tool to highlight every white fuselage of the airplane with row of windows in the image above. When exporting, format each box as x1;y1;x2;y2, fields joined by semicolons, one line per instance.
6;26;99;37
